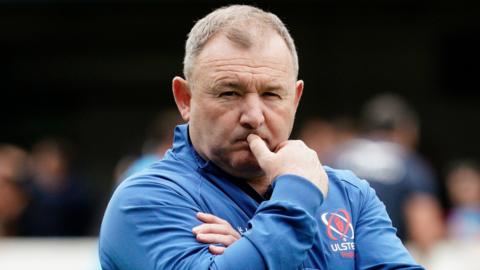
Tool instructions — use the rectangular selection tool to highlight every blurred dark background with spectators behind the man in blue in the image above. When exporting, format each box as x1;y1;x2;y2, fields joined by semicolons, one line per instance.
0;0;480;269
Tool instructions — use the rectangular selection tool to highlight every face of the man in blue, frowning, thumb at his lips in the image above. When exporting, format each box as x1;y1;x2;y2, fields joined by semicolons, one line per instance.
183;33;303;178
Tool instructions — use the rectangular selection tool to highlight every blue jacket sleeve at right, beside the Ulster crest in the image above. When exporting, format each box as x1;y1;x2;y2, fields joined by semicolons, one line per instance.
355;181;424;269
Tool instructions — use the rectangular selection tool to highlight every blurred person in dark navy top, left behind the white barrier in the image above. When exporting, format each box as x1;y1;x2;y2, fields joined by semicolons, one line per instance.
20;139;92;236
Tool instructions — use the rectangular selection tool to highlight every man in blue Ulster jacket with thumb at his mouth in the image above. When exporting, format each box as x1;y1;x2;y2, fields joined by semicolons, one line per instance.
100;6;421;270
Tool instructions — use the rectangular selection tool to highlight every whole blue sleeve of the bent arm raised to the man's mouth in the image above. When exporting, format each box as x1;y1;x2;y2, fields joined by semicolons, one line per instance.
99;175;323;270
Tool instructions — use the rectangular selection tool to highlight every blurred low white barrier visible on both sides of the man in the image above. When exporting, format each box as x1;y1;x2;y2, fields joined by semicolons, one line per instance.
0;238;480;270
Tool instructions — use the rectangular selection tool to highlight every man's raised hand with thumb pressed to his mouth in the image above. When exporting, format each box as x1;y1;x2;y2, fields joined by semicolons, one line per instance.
247;134;328;197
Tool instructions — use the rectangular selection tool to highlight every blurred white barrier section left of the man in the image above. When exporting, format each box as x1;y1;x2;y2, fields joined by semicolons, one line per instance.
0;238;100;270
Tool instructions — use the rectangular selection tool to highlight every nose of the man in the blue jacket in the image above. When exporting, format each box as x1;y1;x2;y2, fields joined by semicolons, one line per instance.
240;93;265;129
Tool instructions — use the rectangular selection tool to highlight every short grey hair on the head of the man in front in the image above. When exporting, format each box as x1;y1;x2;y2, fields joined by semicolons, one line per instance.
183;5;298;80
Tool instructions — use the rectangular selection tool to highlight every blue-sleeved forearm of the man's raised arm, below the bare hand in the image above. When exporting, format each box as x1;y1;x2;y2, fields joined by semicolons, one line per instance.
210;175;323;269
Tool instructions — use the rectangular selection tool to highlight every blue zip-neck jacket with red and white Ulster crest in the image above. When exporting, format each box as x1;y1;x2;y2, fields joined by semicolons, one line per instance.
99;125;423;270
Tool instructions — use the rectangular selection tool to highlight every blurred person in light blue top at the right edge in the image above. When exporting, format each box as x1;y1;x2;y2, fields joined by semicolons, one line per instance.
446;161;480;241
